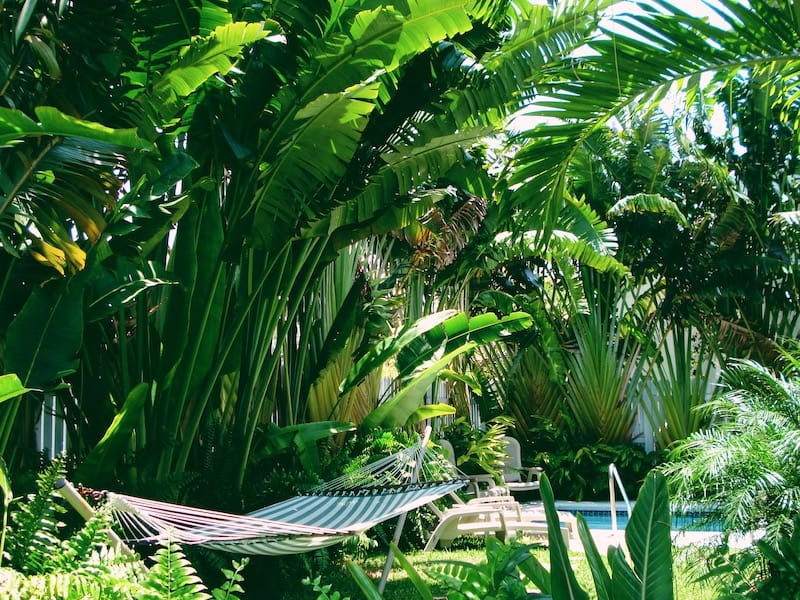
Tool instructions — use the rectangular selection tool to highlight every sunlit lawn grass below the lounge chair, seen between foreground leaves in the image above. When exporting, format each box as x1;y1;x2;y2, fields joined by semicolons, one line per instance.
281;548;717;600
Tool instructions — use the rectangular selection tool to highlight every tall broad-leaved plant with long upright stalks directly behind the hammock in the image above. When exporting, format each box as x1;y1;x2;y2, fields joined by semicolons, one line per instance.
114;1;612;492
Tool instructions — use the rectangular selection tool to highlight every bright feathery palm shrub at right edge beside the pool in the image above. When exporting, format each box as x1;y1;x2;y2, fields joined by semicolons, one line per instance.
662;361;800;541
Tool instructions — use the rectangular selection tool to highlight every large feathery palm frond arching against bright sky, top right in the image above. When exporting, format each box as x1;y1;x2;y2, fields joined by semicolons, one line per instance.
510;0;797;229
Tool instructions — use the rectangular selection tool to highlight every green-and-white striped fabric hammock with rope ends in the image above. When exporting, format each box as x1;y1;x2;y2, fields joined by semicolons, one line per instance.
85;435;467;555
